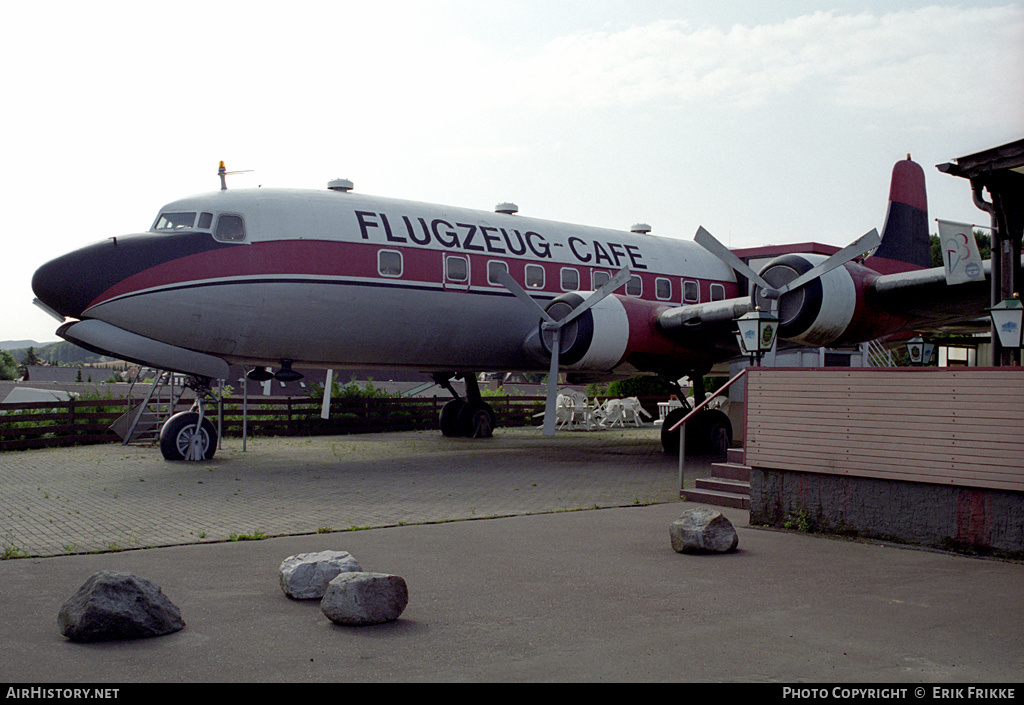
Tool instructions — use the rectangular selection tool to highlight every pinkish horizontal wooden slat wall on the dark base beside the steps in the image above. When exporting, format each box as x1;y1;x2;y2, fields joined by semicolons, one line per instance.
745;367;1024;491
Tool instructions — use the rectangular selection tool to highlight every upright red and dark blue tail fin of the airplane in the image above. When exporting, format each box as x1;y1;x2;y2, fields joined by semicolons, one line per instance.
864;155;932;274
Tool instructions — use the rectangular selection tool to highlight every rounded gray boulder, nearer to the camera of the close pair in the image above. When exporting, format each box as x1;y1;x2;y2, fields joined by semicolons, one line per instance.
321;573;409;626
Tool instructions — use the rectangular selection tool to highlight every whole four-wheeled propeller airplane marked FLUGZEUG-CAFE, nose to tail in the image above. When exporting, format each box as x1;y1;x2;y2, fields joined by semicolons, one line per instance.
32;155;988;460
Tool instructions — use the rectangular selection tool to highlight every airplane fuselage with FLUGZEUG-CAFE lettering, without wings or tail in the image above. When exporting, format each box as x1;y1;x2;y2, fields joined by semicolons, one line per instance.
34;184;739;372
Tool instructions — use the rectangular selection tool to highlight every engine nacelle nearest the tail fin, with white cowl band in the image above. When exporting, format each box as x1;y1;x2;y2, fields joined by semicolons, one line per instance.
753;254;903;346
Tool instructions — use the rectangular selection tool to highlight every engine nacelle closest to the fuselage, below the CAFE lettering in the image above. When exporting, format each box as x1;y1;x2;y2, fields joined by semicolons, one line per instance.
535;292;688;372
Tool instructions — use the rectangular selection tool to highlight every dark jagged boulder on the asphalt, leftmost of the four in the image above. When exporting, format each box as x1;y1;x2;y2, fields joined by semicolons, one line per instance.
57;571;185;641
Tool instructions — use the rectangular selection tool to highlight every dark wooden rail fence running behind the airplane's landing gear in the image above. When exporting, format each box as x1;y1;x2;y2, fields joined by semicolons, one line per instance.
0;397;663;451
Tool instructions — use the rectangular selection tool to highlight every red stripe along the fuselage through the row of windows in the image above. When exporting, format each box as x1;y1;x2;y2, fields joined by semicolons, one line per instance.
81;240;737;307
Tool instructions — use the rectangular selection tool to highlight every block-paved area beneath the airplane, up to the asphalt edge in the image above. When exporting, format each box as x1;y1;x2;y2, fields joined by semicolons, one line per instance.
0;426;699;555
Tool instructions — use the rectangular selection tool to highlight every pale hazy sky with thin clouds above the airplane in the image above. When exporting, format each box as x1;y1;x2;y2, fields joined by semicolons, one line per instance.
0;0;1024;342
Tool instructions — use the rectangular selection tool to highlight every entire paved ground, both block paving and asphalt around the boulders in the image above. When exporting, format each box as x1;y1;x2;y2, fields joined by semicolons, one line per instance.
0;429;1024;684
